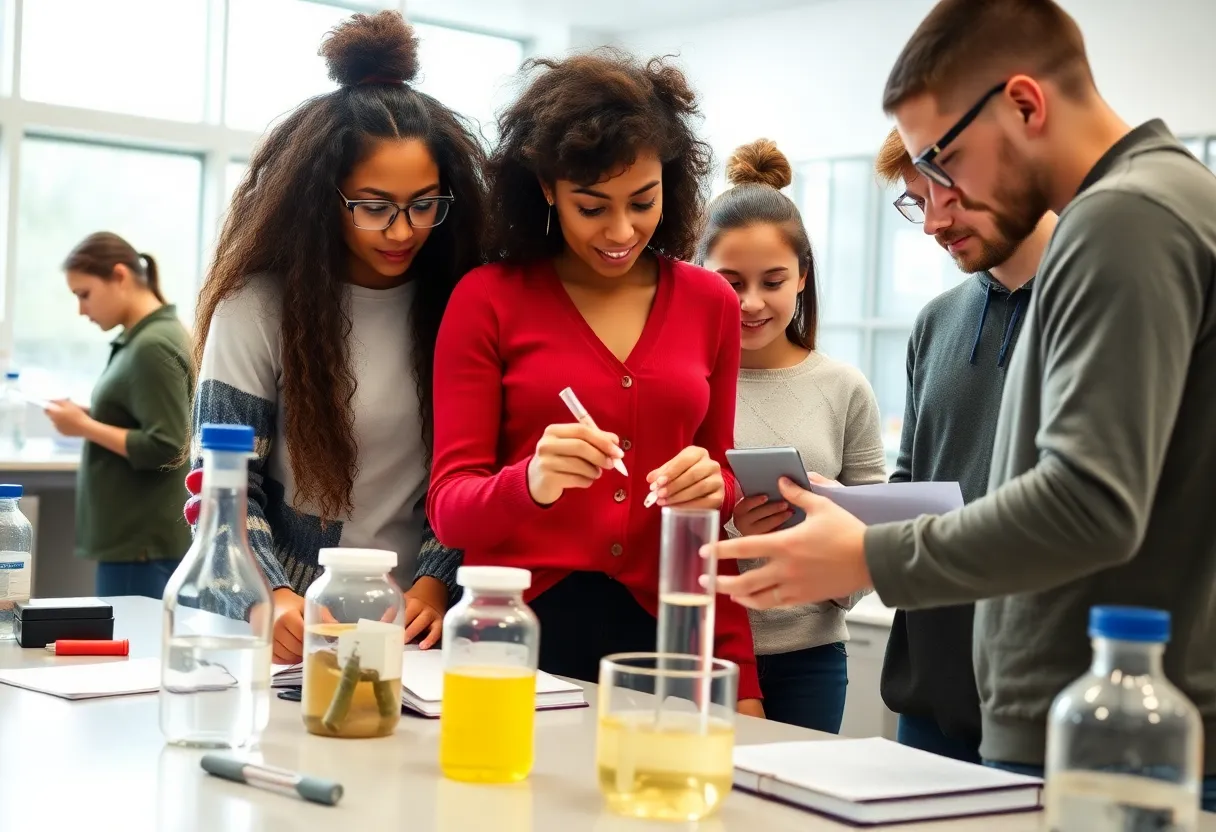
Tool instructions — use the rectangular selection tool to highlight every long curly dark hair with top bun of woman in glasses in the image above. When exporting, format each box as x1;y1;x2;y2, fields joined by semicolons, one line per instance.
193;12;485;519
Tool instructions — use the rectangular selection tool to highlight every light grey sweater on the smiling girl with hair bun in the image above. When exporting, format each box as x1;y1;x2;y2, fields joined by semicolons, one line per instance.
726;352;886;656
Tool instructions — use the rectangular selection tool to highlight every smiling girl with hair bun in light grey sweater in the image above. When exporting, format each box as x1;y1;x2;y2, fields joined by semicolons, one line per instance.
697;139;886;733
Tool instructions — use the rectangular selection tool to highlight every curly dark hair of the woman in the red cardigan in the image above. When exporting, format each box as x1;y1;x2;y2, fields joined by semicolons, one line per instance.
486;49;713;262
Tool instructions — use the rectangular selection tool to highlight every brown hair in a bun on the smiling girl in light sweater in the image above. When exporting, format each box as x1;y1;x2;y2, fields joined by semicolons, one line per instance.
697;139;820;349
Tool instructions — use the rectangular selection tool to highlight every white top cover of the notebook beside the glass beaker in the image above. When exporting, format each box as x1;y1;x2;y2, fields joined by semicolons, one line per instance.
734;737;1042;802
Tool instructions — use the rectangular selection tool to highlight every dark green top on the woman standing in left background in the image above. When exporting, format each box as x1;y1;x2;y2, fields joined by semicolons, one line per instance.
75;305;192;562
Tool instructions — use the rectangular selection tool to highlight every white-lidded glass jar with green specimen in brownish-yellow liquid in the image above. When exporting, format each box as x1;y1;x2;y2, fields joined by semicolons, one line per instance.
302;549;405;737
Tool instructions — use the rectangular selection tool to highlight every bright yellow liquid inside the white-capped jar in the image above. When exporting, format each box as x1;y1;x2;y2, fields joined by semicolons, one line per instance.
439;668;536;783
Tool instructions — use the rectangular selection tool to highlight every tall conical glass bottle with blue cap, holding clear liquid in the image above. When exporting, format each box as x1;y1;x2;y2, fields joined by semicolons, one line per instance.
161;425;274;748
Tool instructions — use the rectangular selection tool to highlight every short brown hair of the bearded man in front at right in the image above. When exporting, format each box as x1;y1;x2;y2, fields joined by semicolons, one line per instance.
883;0;1093;114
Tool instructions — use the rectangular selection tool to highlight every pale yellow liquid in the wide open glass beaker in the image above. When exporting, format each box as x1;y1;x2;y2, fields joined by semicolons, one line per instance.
596;712;734;821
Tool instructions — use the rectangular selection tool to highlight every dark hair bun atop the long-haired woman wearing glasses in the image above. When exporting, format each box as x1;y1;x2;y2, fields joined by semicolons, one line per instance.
320;11;418;86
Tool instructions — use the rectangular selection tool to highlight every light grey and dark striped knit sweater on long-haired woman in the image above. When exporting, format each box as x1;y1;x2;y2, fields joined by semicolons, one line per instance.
191;275;460;595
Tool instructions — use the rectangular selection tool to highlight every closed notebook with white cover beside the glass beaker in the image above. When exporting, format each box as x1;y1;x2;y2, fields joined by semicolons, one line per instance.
734;737;1043;826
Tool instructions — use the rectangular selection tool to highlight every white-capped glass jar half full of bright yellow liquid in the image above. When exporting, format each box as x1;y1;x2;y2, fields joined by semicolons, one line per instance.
439;567;540;783
